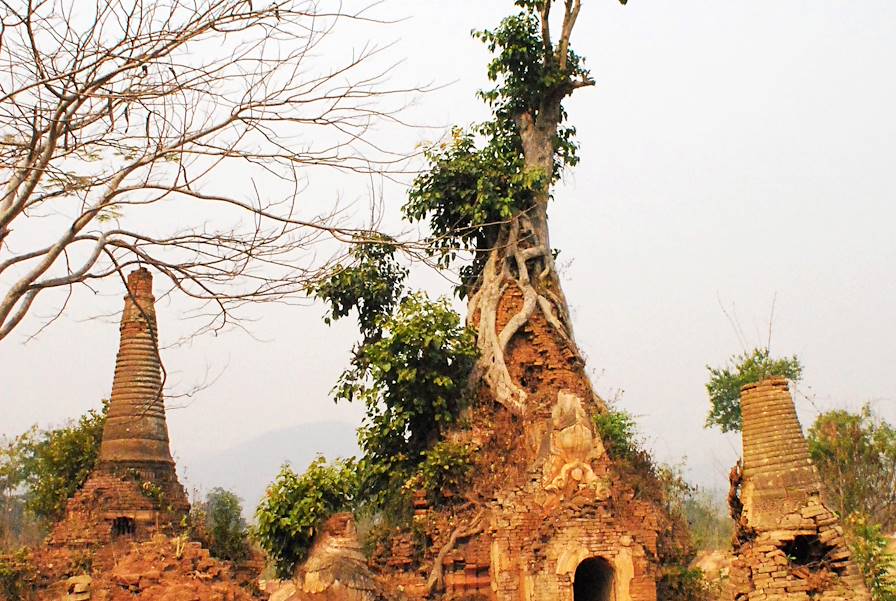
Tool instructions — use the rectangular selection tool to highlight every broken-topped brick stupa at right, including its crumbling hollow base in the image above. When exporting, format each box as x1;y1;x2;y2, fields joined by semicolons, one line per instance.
729;378;870;601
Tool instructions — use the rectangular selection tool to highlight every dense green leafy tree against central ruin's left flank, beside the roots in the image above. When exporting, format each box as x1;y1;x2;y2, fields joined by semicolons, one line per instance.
344;293;484;505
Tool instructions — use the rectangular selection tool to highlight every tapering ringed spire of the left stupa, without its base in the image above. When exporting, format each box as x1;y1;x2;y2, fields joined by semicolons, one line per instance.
99;268;174;472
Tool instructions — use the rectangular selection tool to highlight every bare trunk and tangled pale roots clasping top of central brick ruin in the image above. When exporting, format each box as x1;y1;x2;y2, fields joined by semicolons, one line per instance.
468;100;597;417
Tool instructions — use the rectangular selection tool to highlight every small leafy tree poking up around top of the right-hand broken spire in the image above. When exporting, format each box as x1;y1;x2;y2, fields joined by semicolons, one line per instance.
706;348;803;432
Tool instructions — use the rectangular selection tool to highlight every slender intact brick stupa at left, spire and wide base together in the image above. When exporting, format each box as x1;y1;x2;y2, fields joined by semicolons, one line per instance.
48;268;189;548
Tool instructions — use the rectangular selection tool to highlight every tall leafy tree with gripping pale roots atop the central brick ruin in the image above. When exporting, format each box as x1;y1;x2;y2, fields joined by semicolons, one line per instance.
405;0;624;416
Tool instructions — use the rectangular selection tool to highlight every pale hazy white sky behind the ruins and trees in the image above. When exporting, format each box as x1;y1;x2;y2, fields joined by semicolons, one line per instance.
0;0;896;496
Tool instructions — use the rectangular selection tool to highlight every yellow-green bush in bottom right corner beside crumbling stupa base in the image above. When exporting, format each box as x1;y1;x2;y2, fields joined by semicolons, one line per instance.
846;514;896;601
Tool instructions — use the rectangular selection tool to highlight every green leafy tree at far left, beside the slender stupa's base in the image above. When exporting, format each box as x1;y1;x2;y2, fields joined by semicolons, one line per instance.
0;402;108;521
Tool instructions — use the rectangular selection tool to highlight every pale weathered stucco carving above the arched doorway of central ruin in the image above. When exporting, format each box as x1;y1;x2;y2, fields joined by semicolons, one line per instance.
544;391;604;491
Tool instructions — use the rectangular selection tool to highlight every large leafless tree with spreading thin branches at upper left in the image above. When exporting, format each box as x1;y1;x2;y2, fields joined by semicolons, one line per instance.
0;0;413;340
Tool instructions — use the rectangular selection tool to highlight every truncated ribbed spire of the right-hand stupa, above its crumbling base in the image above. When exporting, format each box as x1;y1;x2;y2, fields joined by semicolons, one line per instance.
741;378;821;530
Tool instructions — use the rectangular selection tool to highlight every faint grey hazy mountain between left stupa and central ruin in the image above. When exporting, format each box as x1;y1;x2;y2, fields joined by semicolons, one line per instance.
179;422;358;517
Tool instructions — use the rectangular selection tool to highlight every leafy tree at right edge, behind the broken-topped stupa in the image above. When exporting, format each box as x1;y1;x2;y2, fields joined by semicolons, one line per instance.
808;405;896;530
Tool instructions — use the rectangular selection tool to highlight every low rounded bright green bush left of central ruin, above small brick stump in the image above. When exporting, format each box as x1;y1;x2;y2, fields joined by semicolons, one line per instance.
253;457;356;578
